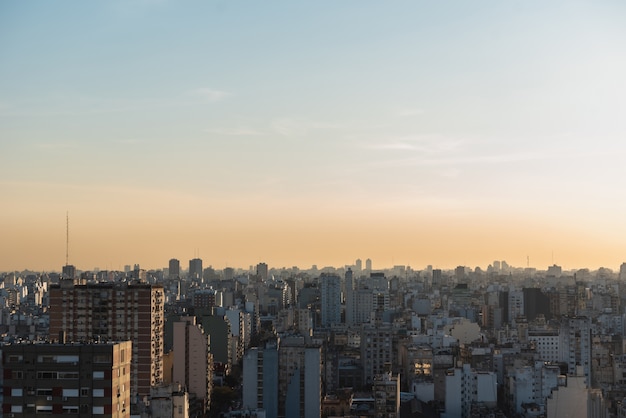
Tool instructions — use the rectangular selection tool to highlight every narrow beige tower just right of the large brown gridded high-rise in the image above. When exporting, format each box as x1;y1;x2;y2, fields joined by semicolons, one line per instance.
172;316;213;412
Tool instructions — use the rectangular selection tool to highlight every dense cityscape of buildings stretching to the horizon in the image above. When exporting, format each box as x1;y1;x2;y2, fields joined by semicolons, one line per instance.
0;258;626;418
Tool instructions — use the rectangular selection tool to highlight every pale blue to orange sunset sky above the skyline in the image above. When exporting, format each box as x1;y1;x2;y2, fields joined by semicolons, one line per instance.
0;0;626;271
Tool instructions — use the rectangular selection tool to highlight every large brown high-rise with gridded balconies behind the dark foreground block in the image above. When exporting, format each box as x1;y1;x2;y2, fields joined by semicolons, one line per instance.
49;280;164;402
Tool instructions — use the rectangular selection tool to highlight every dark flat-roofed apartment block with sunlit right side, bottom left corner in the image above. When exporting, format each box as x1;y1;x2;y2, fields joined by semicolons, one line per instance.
1;341;132;418
